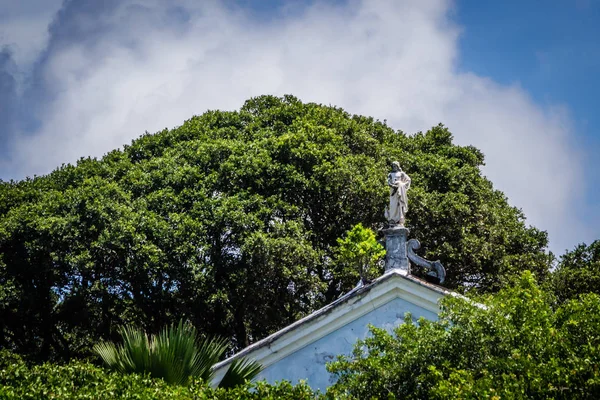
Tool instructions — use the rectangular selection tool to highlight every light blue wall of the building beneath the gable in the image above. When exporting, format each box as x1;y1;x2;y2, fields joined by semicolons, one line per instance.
257;298;437;392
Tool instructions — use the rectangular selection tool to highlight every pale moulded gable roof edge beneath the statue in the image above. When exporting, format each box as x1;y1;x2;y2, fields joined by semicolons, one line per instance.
213;269;451;382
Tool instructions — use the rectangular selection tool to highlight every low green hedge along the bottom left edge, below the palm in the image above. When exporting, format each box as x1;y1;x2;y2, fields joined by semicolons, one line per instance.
0;351;318;400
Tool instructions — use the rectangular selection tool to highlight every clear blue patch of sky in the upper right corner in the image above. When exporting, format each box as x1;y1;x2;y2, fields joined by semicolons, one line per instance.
455;0;600;146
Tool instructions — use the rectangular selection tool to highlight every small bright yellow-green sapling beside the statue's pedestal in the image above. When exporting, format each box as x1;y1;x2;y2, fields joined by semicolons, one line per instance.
335;223;385;286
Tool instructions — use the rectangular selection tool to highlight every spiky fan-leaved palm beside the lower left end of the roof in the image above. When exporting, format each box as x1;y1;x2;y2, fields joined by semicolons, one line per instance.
94;320;261;387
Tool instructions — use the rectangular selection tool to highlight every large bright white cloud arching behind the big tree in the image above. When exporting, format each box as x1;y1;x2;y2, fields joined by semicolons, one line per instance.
0;0;589;252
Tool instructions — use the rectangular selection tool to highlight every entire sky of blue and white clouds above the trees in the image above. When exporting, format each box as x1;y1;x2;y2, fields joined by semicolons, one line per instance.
0;0;600;255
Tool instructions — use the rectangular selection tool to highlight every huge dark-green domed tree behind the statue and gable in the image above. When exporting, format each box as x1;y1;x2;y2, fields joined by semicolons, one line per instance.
0;96;548;359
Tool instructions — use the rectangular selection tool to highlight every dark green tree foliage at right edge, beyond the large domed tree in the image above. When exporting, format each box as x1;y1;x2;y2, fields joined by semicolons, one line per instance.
549;240;600;302
